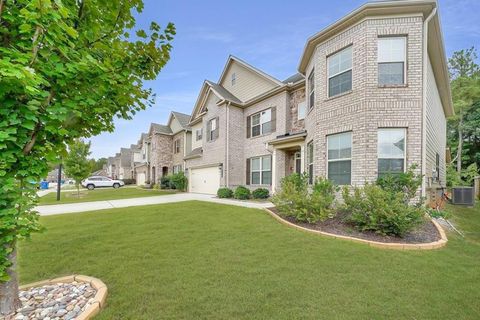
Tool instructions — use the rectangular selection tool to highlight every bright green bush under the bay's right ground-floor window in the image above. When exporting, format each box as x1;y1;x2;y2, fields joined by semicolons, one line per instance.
377;164;422;203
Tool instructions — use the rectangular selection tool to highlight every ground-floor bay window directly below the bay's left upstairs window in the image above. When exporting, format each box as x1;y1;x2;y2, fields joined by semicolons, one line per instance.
327;132;352;185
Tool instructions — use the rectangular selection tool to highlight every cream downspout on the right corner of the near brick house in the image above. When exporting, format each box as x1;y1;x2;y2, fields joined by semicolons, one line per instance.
421;8;437;197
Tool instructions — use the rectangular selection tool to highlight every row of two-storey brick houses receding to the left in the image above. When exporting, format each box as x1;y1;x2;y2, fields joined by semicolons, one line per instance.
109;0;453;199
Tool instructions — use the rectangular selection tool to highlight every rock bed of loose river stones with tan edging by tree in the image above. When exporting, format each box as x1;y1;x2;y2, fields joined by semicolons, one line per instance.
6;276;107;320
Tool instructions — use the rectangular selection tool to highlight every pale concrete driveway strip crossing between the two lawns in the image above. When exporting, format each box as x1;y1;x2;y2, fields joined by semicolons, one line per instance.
35;193;273;216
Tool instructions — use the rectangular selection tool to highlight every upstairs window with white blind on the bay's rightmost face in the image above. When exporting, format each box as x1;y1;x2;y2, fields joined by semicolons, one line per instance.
378;36;407;86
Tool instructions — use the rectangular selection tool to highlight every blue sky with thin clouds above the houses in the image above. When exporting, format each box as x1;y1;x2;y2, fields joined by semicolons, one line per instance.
91;0;480;159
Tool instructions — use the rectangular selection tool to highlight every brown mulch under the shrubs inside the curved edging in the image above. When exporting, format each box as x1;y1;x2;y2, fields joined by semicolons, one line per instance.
268;208;441;244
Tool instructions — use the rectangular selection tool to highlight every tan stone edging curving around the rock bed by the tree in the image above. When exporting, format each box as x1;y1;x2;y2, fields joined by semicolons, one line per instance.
20;275;108;320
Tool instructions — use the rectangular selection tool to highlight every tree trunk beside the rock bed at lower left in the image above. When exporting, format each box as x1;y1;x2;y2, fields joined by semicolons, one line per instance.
0;245;22;316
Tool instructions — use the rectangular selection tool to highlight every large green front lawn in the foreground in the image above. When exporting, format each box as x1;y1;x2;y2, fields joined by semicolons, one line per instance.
19;202;480;319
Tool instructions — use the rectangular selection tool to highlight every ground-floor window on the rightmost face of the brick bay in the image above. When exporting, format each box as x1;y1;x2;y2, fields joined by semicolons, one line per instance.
378;128;406;177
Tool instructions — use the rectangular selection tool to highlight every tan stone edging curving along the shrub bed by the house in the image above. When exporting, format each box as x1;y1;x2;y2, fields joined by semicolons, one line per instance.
265;208;448;250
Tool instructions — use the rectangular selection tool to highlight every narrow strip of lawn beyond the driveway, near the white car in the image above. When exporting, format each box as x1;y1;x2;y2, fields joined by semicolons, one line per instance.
39;187;173;205
